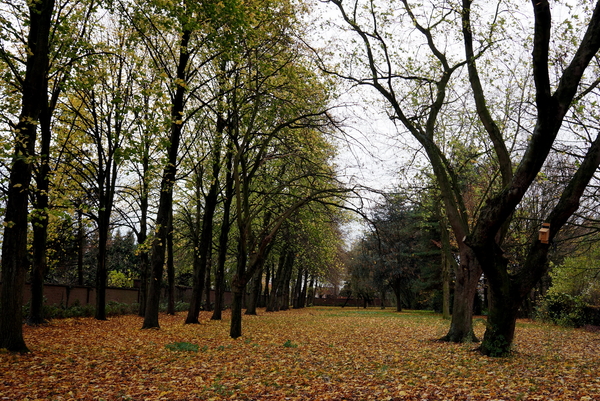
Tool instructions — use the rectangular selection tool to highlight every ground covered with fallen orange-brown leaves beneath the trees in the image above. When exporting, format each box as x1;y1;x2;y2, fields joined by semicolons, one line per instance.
0;308;600;401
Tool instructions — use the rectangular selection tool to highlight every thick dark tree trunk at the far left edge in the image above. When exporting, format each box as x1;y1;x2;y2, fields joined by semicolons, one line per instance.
0;0;54;352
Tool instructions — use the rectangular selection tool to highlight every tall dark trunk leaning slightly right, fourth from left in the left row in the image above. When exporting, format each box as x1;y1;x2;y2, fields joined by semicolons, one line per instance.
142;29;192;329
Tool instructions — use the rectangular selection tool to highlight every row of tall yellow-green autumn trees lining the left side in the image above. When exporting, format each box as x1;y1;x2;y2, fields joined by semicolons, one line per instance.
0;0;346;351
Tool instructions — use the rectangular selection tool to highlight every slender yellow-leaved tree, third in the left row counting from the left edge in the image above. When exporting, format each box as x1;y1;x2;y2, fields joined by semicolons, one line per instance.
65;24;137;320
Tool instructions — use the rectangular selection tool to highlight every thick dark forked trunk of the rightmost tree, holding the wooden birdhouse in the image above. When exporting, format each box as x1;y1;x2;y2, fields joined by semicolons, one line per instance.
463;0;600;356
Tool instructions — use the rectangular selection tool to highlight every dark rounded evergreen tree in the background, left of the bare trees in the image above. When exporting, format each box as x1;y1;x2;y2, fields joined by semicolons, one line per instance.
348;194;440;312
